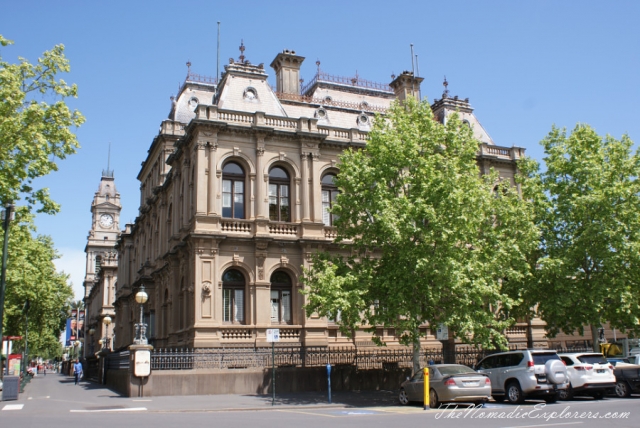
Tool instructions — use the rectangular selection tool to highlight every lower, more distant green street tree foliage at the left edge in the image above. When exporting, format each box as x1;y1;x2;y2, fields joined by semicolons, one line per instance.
0;208;73;356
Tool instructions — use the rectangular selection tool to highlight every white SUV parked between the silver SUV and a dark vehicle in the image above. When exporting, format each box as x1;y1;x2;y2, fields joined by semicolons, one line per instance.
558;352;616;400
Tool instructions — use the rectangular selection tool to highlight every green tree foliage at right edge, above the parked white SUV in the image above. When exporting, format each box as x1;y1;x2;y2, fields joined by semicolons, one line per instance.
521;125;640;344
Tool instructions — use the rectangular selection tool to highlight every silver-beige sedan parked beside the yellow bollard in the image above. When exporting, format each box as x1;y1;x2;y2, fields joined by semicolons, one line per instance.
398;364;491;408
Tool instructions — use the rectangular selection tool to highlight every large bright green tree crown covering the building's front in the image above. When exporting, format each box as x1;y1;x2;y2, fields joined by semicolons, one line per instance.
304;99;538;354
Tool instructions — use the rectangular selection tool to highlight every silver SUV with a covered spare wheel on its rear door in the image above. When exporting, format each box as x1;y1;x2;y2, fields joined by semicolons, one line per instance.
475;349;569;404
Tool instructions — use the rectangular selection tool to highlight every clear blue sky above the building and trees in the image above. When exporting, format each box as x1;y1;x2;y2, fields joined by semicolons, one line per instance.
0;0;640;298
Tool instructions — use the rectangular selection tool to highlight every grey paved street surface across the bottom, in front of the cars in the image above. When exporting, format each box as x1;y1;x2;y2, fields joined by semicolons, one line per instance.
0;374;640;428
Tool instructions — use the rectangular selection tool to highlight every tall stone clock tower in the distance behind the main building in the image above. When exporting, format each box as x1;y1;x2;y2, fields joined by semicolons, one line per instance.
83;169;122;355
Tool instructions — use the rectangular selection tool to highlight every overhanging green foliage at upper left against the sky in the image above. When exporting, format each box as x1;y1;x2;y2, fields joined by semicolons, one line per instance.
0;35;84;213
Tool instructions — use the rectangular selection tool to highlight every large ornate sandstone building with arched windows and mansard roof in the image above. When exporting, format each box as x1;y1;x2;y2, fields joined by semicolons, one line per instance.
111;50;526;348
